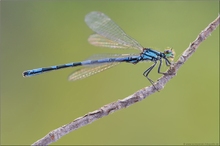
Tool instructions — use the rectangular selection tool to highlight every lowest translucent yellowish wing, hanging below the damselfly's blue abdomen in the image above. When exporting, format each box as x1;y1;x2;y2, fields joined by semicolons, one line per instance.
68;62;119;81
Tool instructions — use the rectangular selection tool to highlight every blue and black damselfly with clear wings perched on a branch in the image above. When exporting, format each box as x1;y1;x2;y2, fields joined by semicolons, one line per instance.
23;12;174;89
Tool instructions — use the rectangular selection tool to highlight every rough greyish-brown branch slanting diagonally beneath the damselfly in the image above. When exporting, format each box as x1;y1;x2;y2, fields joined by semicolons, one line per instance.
32;16;220;145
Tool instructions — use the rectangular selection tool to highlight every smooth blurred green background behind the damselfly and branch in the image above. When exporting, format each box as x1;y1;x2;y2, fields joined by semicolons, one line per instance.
0;1;219;145
